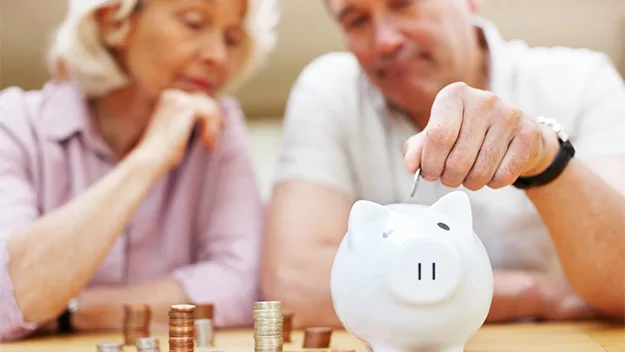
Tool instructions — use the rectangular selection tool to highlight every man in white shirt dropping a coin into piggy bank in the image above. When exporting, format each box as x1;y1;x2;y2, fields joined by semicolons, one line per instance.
262;0;625;326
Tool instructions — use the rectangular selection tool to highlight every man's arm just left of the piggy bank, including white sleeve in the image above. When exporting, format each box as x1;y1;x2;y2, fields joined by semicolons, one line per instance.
261;54;354;326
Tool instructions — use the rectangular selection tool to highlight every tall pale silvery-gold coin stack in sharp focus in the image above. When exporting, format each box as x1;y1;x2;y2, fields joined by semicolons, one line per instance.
254;301;284;352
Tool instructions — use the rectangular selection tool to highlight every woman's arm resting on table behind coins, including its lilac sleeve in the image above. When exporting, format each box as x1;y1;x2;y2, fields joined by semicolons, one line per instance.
65;96;263;330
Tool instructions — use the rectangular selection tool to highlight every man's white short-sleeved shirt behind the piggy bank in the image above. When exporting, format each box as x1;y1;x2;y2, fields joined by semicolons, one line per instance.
276;20;625;271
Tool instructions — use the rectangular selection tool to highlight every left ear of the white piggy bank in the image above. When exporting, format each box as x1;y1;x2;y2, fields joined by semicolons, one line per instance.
347;200;390;249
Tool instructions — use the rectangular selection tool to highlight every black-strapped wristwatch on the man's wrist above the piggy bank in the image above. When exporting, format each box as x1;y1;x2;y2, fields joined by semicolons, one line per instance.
513;116;575;189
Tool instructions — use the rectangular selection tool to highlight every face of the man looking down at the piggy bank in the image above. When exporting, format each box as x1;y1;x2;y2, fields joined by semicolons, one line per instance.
328;0;478;116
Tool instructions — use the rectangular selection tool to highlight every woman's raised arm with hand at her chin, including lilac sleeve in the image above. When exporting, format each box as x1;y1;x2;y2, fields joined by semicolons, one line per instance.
0;86;221;340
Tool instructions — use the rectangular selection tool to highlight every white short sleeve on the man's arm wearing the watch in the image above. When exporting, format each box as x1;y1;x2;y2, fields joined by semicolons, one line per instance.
573;56;625;161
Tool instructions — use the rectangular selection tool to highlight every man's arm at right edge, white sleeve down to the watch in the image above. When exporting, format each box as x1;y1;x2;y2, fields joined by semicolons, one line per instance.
526;58;625;317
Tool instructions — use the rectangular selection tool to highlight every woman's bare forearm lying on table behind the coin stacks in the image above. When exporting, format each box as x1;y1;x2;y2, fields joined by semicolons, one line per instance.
74;276;187;331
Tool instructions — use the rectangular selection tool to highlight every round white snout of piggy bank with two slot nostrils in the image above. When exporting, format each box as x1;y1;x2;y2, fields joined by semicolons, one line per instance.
387;237;462;304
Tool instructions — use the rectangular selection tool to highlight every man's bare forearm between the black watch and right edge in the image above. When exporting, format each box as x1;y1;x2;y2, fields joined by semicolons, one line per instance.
527;159;625;316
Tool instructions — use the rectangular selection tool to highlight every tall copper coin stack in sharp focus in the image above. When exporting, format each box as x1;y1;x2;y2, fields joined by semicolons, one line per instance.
169;304;195;352
